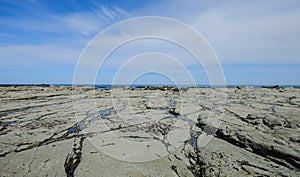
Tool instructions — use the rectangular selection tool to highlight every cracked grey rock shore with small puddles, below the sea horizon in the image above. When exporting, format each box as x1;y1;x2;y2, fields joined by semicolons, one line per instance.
0;86;300;177
